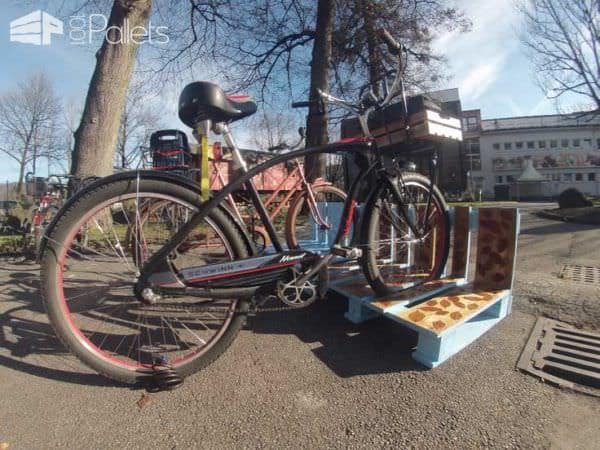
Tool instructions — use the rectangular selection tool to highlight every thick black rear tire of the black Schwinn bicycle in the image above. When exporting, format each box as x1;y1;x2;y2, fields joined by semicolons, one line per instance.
41;178;249;384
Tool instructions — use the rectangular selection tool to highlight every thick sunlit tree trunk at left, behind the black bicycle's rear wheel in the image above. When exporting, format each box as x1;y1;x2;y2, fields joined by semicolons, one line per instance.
71;0;152;178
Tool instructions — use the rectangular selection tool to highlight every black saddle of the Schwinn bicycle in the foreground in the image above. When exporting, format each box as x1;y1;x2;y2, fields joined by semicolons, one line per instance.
179;81;256;128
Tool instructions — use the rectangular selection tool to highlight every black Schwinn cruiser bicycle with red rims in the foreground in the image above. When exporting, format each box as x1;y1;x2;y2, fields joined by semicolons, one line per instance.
41;32;450;386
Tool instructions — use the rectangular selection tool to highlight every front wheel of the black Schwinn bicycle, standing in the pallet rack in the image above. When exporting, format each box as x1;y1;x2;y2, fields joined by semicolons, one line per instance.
361;173;450;296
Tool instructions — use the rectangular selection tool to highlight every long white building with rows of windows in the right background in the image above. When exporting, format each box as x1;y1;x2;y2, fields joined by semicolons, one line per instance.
462;110;600;200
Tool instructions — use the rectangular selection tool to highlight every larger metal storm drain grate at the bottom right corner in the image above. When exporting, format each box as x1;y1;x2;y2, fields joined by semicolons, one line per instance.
517;317;600;396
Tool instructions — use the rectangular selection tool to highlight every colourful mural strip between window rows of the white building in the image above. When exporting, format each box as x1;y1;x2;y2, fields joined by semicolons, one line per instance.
492;152;600;170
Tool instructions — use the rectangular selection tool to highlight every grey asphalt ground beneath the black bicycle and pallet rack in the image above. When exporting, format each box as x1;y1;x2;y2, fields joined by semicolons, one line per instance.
0;208;600;449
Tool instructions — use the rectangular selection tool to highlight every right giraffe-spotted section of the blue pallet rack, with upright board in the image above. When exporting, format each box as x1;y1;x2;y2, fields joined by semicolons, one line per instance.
386;208;519;368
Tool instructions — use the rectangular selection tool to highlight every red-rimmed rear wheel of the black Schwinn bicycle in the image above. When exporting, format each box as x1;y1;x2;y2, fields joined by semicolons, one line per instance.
42;179;248;383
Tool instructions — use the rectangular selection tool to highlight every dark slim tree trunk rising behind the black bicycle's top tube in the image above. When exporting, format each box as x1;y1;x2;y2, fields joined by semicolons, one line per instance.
306;0;335;181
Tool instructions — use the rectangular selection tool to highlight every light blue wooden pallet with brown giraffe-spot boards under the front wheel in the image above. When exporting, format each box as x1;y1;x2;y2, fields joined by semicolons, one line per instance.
332;208;519;368
